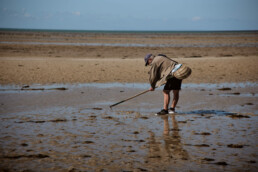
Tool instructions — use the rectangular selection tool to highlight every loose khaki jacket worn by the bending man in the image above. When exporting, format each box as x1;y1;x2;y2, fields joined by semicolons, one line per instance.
149;56;177;88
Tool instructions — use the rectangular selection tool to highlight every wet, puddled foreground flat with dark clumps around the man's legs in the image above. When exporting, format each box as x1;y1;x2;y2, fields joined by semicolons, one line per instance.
0;83;258;171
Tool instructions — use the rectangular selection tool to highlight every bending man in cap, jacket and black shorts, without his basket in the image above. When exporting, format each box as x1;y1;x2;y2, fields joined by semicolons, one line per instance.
144;54;182;115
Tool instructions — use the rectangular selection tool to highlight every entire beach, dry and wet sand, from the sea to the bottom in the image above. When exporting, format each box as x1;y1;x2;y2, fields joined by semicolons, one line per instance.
0;31;258;172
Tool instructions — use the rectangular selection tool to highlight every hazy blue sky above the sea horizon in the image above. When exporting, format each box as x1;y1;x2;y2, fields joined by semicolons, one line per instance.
0;0;258;31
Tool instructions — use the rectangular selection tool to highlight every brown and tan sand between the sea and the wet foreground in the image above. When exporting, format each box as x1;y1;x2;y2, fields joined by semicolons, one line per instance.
0;31;258;84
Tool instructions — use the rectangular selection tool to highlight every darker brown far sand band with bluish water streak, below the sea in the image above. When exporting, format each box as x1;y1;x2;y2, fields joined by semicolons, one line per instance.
0;31;258;59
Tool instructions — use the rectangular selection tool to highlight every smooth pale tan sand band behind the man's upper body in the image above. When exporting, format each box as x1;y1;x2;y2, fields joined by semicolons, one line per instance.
0;57;258;85
